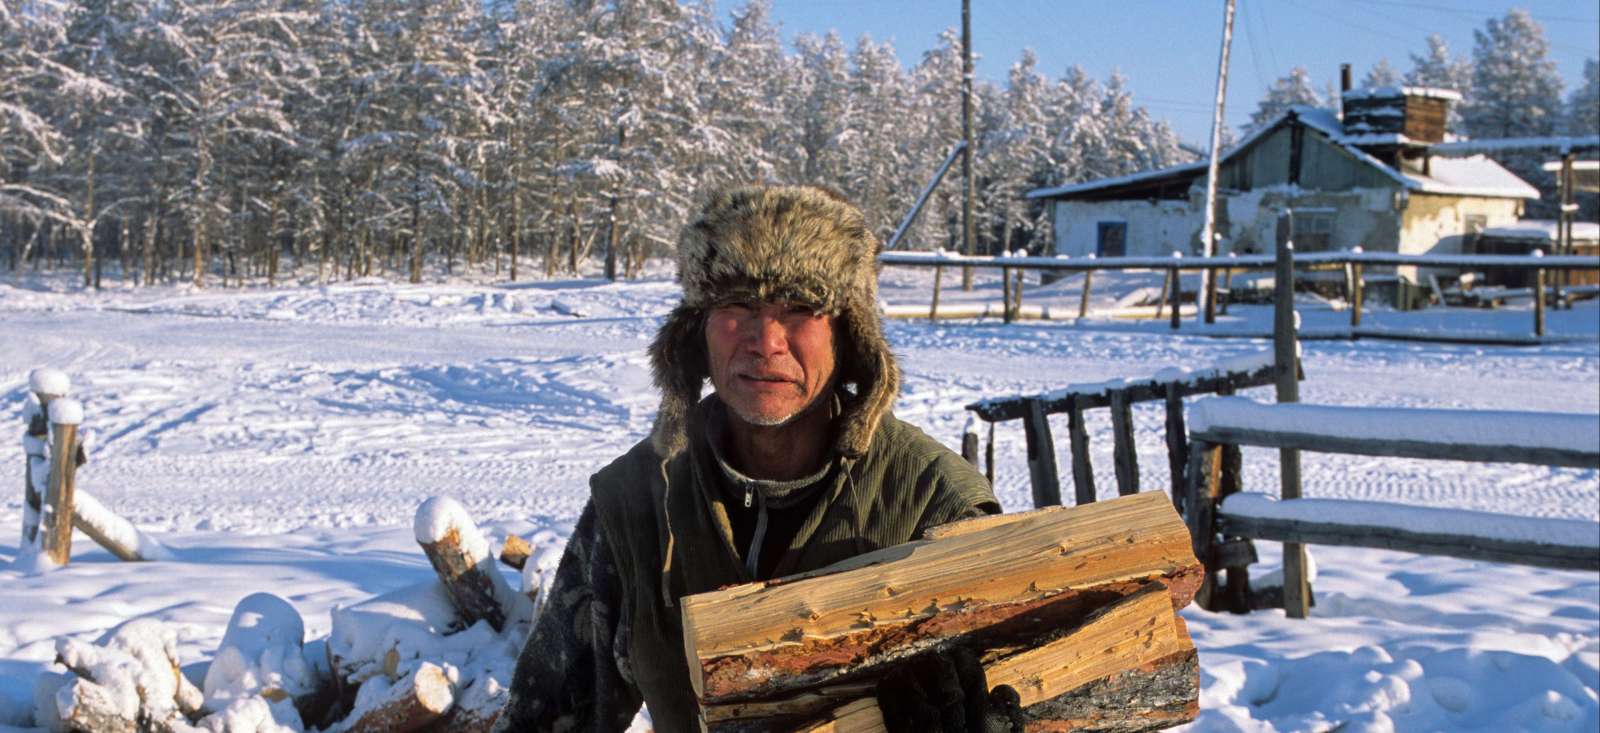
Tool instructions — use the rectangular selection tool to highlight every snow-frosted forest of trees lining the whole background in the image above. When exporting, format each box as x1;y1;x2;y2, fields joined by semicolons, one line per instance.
0;0;1600;286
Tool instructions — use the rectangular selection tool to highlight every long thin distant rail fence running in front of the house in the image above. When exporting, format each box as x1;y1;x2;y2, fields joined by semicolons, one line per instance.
878;250;1600;336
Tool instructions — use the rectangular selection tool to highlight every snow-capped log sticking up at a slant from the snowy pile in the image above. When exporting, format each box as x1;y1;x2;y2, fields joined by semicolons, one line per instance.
411;496;533;631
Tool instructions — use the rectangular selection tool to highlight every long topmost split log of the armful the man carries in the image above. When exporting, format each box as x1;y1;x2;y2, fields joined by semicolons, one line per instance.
683;493;1202;704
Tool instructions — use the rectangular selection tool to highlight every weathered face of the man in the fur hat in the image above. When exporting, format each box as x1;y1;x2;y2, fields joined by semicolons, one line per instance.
706;302;834;426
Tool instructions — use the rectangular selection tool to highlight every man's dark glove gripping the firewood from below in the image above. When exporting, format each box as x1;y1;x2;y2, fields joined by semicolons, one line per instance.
877;647;1024;733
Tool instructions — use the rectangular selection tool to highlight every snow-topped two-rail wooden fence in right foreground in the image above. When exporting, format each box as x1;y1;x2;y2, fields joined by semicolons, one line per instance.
1181;397;1600;618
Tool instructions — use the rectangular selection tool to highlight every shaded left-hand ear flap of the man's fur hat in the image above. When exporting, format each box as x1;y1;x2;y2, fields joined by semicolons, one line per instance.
650;304;710;458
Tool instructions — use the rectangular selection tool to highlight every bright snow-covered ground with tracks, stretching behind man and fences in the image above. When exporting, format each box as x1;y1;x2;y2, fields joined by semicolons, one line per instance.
0;269;1600;733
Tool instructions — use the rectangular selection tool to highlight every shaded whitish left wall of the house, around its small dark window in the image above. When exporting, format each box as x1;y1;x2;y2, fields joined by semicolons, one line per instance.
1054;202;1202;258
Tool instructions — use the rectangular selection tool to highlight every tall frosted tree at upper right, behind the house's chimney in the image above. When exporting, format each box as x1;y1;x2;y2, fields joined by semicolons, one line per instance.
1461;8;1562;138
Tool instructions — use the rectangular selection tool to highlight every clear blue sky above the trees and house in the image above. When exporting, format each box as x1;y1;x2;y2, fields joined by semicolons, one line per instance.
764;0;1600;144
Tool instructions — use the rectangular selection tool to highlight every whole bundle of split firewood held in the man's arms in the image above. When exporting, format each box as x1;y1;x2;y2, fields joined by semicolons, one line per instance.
683;493;1202;731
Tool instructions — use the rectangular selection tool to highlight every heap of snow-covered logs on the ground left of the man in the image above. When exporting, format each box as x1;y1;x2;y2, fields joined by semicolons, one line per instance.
35;499;563;733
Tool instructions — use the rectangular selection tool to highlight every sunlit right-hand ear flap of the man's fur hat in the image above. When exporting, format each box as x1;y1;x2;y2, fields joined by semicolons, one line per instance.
834;298;899;458
